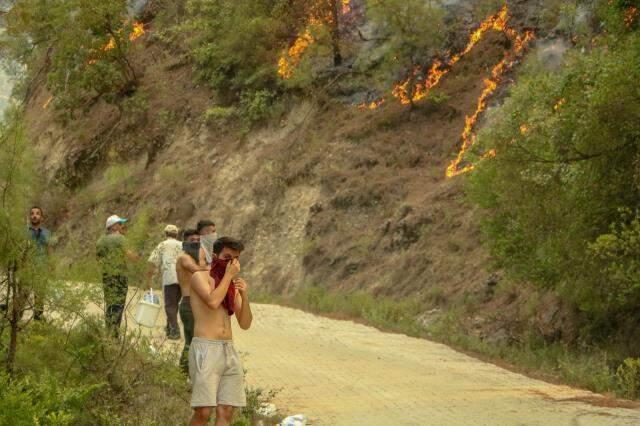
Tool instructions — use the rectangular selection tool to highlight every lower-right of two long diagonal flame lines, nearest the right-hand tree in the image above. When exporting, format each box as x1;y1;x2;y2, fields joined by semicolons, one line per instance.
446;31;534;178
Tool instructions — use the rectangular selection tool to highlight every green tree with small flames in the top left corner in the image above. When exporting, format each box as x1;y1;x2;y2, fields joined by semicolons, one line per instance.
0;0;141;111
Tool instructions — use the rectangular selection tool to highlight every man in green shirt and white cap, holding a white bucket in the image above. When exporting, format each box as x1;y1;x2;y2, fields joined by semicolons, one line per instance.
96;215;139;337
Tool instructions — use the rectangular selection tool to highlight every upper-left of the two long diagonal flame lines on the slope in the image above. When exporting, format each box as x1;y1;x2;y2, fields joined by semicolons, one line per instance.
391;5;516;105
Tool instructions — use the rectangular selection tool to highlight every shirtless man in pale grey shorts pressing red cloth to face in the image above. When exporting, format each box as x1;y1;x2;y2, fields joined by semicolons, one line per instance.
189;237;253;426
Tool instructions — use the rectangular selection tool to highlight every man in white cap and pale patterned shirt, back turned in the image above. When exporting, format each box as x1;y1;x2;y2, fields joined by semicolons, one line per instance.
147;225;182;340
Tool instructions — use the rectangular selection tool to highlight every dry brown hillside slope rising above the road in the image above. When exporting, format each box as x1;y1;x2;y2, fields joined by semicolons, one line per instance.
22;1;570;340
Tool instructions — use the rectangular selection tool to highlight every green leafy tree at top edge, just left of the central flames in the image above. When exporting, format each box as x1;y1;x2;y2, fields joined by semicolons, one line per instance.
179;0;287;103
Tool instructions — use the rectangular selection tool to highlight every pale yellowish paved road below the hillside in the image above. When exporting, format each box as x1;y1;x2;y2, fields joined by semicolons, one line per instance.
116;292;640;426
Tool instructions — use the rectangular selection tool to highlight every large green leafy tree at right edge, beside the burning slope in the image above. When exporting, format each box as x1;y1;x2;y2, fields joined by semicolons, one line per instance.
468;9;640;314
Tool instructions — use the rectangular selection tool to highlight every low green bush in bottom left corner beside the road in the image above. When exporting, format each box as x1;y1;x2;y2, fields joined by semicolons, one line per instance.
0;318;190;425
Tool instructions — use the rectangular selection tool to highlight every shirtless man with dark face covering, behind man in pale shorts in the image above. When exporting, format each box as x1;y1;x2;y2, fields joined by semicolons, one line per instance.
176;229;209;374
